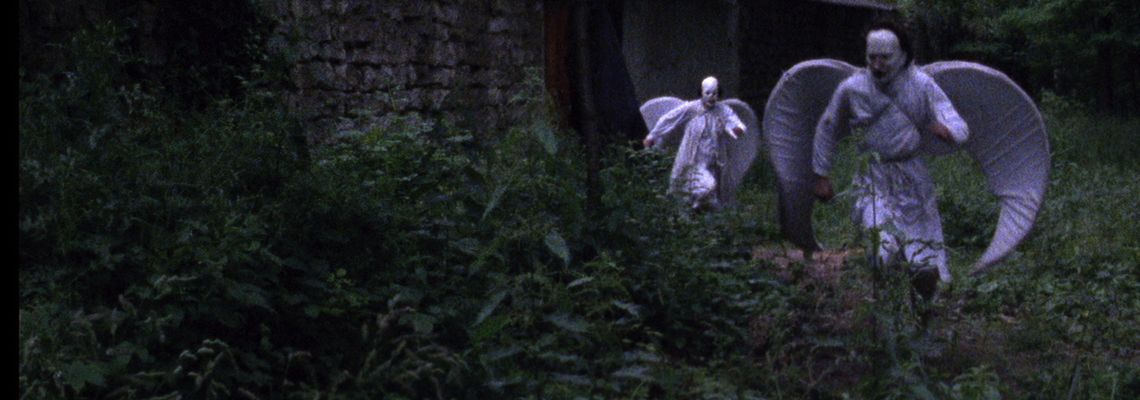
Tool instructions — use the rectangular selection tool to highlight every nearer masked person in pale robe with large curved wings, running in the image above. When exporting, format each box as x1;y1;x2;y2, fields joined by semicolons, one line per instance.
764;22;1049;295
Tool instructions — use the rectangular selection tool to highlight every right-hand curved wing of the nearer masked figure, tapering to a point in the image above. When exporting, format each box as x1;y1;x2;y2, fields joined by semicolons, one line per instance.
922;62;1050;275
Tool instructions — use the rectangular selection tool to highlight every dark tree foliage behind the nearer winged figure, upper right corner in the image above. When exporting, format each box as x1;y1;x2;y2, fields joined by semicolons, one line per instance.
898;0;1140;114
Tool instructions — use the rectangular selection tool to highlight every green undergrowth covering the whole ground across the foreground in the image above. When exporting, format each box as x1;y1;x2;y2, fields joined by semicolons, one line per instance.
19;26;1140;399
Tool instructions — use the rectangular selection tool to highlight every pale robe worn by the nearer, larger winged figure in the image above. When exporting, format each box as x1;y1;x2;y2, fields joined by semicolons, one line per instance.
812;66;969;281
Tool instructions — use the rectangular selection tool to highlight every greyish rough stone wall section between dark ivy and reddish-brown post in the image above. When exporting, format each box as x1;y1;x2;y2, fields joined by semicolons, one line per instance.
262;0;543;141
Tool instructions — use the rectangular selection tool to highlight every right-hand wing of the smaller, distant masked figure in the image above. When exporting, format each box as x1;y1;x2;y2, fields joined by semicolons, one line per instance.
717;99;760;205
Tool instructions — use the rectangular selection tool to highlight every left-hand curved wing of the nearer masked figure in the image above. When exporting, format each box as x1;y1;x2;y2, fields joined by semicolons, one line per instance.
764;59;856;251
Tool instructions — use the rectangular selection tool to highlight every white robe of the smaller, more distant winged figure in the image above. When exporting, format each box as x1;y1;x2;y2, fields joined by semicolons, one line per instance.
649;100;746;209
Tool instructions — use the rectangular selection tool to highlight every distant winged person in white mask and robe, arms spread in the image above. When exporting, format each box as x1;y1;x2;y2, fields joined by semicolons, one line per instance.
641;76;760;210
